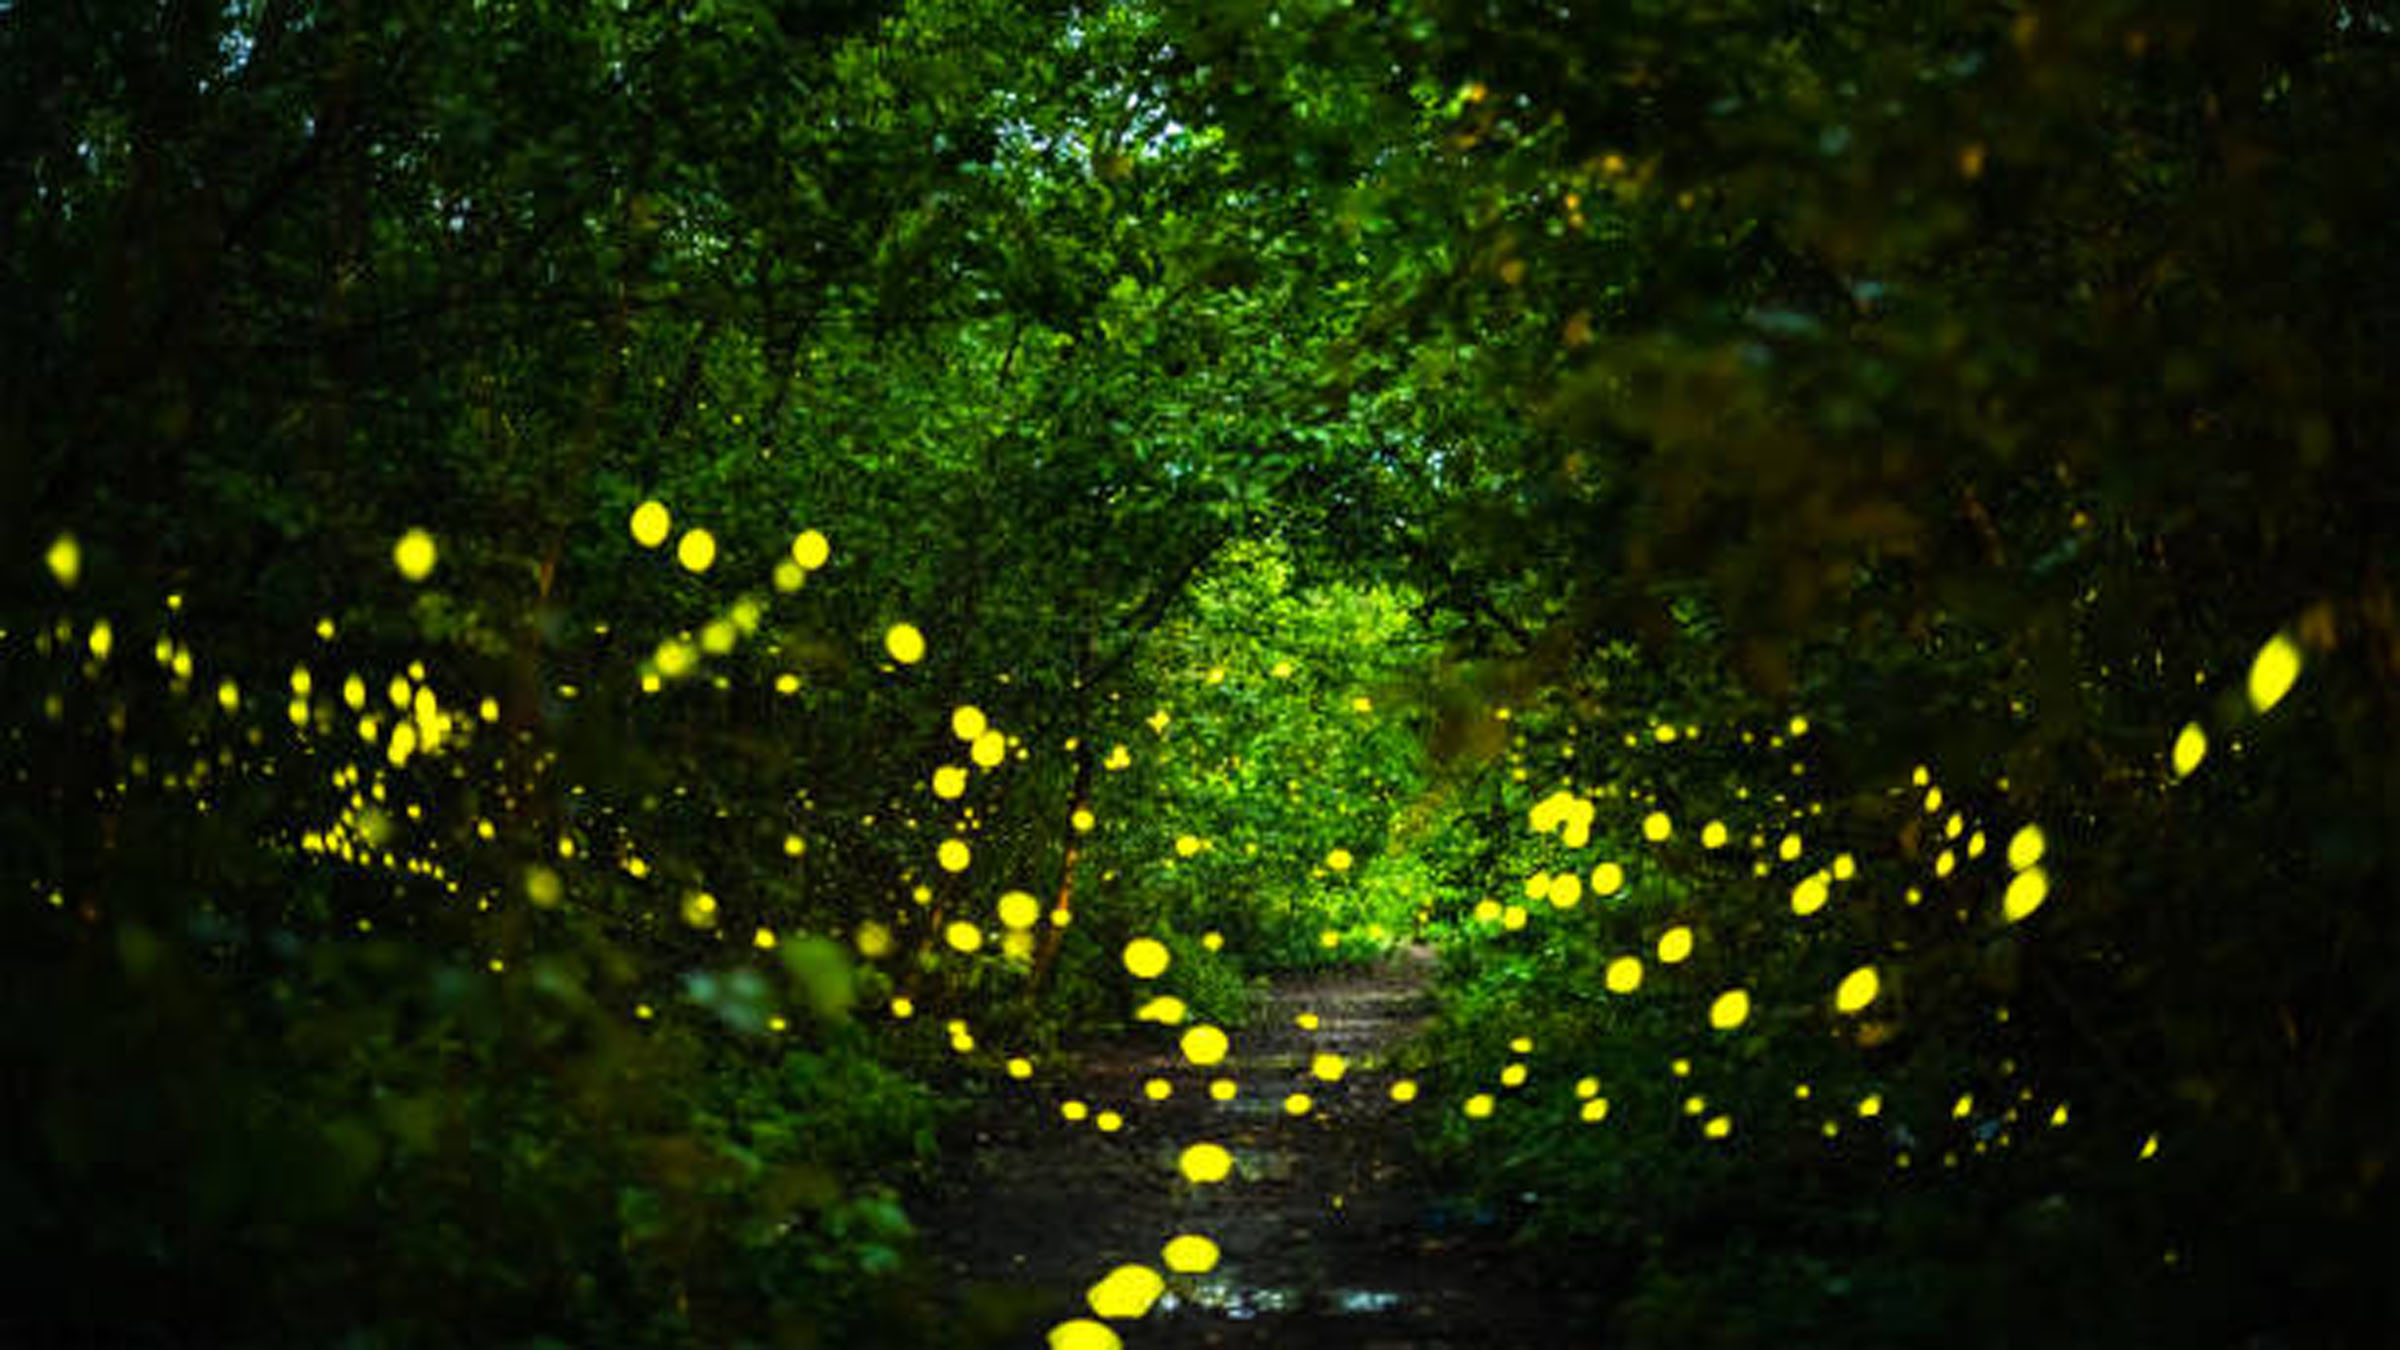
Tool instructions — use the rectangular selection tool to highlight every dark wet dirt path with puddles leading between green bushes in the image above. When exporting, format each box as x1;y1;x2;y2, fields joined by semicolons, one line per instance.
917;949;1603;1350
